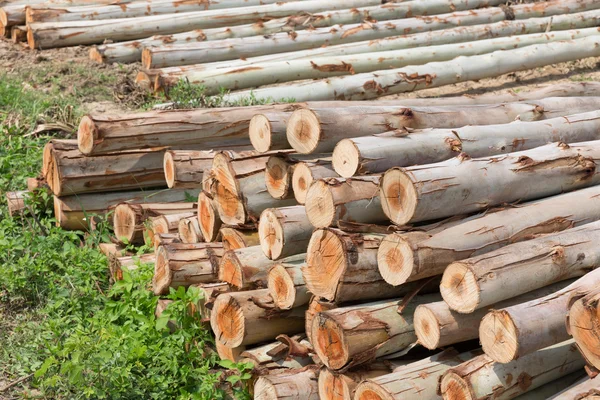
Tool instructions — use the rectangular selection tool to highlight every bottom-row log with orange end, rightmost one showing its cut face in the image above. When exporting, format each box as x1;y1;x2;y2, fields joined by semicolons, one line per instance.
440;340;584;400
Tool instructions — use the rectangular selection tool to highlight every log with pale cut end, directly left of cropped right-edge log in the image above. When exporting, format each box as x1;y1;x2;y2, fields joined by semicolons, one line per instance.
479;270;600;363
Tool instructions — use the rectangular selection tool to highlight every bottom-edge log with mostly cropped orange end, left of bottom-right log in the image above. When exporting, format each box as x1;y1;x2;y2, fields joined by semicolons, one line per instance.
354;349;479;400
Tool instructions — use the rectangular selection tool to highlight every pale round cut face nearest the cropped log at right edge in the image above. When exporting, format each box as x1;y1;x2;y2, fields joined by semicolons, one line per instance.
479;310;519;364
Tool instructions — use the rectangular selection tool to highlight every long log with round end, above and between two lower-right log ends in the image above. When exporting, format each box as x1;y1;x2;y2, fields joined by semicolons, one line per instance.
440;221;600;314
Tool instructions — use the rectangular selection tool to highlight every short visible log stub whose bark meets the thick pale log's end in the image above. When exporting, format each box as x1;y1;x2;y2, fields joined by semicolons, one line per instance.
305;175;388;228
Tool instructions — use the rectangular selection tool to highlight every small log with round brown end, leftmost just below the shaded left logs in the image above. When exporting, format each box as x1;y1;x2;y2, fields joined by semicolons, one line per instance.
112;202;197;244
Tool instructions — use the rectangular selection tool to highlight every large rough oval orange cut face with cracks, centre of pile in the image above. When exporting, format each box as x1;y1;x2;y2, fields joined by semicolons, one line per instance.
302;229;348;301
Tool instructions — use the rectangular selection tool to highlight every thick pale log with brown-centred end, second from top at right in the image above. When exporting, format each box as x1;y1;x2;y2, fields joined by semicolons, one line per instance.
380;142;600;225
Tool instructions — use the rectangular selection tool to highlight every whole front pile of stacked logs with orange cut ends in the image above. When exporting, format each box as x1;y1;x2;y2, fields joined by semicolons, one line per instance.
7;79;600;400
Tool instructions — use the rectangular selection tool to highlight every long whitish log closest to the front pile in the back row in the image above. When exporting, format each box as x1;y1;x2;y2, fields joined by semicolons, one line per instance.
225;36;600;101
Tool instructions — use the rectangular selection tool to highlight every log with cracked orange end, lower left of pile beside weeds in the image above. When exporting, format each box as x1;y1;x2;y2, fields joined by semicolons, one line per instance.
210;289;305;347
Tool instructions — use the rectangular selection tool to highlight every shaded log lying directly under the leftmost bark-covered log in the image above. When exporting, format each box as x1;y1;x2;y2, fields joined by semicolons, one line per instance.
54;189;199;230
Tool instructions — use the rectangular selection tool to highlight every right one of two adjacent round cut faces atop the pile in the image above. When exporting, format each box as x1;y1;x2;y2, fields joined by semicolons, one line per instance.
286;109;321;154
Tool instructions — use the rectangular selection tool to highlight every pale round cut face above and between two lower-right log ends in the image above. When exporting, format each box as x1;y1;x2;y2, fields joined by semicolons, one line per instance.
440;262;479;314
